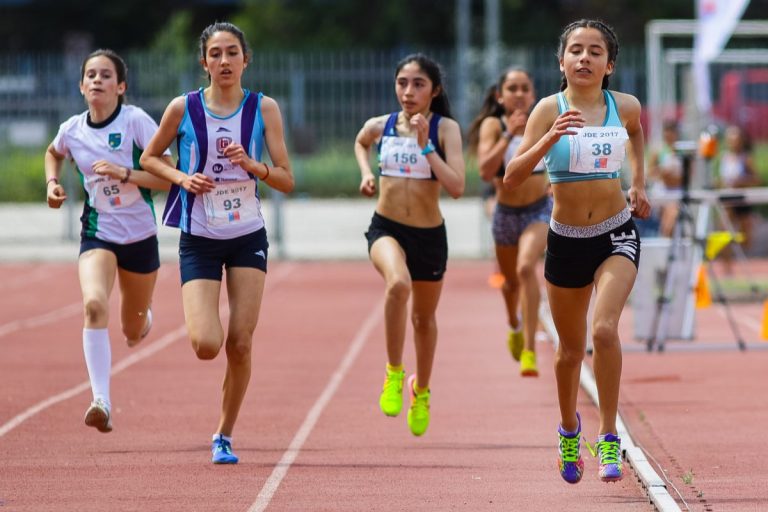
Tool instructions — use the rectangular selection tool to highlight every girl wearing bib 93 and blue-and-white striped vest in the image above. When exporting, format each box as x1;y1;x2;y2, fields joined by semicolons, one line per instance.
141;23;293;464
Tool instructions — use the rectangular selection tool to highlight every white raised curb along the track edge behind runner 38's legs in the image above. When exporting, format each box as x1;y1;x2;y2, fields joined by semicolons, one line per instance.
539;302;682;512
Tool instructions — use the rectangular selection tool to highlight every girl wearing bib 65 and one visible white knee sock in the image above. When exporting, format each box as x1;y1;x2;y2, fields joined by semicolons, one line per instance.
45;50;170;432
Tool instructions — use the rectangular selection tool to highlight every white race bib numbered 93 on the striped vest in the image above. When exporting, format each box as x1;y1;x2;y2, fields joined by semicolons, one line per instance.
203;180;261;226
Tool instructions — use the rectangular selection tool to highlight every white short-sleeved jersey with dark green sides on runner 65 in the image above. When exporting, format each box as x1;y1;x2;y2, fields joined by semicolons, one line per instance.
53;105;170;244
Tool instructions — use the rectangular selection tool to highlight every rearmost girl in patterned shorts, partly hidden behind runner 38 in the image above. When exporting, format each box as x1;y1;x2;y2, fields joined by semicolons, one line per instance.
469;68;552;377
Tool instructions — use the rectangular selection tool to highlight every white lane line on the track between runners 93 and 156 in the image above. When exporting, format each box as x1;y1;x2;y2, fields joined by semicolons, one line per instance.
248;298;384;512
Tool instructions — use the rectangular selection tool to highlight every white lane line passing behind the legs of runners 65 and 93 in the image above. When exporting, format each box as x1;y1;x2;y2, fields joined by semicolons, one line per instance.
0;264;294;438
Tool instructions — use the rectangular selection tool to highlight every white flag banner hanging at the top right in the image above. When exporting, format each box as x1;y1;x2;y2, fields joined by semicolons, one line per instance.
693;0;749;114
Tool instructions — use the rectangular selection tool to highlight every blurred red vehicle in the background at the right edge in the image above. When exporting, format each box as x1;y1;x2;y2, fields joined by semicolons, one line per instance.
713;68;768;140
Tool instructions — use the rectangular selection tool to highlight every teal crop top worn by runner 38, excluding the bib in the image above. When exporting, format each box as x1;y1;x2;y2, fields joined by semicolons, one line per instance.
544;89;624;183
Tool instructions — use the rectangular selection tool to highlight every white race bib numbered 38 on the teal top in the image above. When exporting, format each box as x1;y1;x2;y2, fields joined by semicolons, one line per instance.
568;126;629;174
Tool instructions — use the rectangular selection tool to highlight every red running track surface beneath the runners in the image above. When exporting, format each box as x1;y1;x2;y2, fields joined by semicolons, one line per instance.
0;262;768;512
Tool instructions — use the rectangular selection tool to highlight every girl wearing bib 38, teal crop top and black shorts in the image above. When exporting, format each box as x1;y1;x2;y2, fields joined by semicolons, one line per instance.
504;20;650;483
